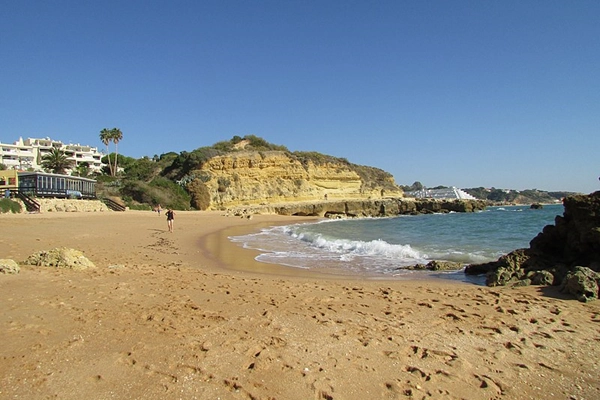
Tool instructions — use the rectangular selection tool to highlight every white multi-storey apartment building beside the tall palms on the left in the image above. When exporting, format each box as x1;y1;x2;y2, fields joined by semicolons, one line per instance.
0;138;104;171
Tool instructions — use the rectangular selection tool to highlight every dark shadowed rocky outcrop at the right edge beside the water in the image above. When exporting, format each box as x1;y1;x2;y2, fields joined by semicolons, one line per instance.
465;191;600;300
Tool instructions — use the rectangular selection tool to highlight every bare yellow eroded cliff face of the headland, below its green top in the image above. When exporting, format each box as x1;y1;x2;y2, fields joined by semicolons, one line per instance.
188;151;402;209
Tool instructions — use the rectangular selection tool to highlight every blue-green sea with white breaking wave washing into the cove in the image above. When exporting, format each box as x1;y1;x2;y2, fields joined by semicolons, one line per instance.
230;204;564;283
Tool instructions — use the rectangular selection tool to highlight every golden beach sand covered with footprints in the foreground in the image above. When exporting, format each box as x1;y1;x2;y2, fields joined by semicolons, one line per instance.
0;211;600;400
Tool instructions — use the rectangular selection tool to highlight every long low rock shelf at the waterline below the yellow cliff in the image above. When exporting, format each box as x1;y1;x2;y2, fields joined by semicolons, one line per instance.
228;198;486;218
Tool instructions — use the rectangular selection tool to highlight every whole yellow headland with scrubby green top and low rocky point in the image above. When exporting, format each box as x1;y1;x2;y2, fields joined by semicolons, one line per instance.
166;142;487;218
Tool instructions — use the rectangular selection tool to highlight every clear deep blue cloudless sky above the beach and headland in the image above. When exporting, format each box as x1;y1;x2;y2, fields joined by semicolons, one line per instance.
0;0;600;193
